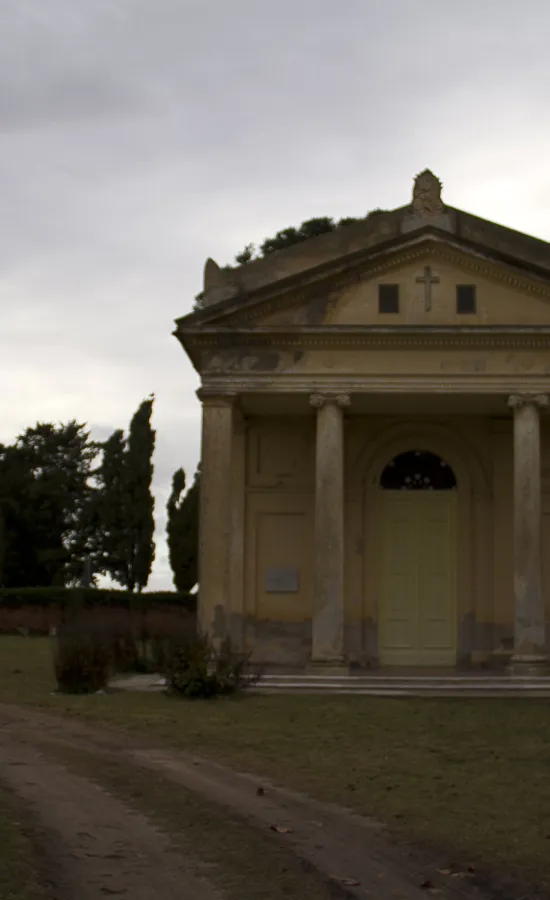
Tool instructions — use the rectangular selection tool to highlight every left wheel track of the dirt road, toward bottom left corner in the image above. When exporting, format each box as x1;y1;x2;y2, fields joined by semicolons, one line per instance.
0;735;220;900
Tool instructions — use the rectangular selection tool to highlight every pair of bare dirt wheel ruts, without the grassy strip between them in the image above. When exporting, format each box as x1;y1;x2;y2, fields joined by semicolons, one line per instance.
0;706;517;900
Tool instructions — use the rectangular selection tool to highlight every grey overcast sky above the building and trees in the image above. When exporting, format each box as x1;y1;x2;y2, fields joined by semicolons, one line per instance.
0;0;550;588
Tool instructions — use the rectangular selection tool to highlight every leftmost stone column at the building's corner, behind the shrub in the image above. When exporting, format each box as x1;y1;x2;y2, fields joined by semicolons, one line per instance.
197;389;235;642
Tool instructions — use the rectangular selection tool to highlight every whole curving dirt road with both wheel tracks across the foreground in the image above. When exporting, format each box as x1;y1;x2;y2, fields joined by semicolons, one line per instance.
0;706;519;900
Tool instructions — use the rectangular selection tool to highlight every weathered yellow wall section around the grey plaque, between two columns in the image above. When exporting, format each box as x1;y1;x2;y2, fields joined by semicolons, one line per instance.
245;417;315;664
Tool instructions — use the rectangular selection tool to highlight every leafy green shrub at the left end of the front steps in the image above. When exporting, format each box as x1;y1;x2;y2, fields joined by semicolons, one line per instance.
162;637;260;699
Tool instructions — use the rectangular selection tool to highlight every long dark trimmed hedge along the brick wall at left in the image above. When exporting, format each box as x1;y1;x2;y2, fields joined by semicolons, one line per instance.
0;587;197;613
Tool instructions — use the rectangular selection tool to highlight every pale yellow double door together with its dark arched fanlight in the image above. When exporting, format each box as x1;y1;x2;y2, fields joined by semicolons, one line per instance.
379;450;457;666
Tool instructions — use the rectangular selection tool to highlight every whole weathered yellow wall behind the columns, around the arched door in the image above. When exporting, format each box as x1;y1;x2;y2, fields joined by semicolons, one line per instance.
244;415;550;665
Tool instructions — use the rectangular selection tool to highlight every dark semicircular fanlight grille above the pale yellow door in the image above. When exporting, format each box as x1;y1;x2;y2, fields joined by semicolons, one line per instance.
380;450;456;491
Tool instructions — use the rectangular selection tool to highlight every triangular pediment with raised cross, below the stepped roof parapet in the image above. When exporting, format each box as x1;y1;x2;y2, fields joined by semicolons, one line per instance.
181;229;550;332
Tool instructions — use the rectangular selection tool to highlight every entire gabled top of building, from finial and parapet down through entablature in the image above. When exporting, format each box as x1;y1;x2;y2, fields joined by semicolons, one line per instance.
175;170;550;380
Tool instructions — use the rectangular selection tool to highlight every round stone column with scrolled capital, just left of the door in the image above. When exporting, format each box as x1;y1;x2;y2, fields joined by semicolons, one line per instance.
310;394;350;666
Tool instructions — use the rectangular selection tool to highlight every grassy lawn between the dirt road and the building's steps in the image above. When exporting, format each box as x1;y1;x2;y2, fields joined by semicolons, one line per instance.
0;637;550;890
